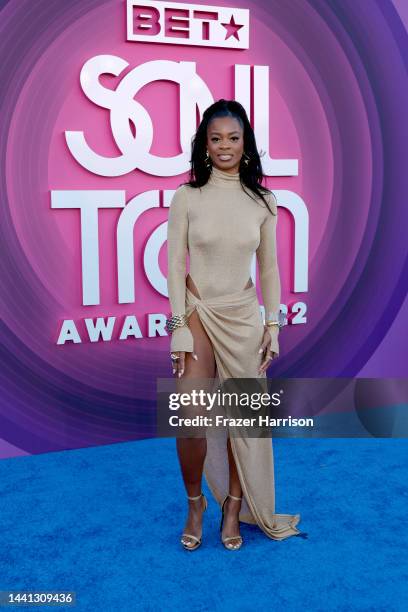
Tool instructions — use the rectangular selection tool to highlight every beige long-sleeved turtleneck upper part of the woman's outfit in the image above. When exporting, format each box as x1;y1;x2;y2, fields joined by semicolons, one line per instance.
167;166;281;353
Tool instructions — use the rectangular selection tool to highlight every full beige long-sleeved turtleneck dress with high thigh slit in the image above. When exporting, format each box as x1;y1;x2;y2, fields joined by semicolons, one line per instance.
167;166;301;540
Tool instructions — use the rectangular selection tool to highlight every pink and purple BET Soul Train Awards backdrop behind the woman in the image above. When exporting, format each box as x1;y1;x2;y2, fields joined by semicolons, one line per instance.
0;0;408;457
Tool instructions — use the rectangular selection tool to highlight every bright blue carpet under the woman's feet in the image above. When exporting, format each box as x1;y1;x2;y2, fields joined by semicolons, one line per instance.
0;439;408;612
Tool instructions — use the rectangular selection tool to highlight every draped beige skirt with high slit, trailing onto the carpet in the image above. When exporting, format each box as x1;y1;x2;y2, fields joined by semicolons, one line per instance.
185;285;301;540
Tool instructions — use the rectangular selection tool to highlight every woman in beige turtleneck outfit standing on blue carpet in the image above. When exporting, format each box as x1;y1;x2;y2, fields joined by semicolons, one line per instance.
167;99;300;550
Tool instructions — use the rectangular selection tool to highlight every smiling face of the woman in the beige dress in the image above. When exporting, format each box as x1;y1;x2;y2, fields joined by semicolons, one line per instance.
207;117;244;173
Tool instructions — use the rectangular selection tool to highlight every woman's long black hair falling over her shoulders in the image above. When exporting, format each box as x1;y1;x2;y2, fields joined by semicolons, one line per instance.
183;98;275;214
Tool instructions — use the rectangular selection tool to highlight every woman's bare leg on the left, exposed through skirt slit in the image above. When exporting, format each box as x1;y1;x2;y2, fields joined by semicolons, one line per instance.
176;298;215;546
